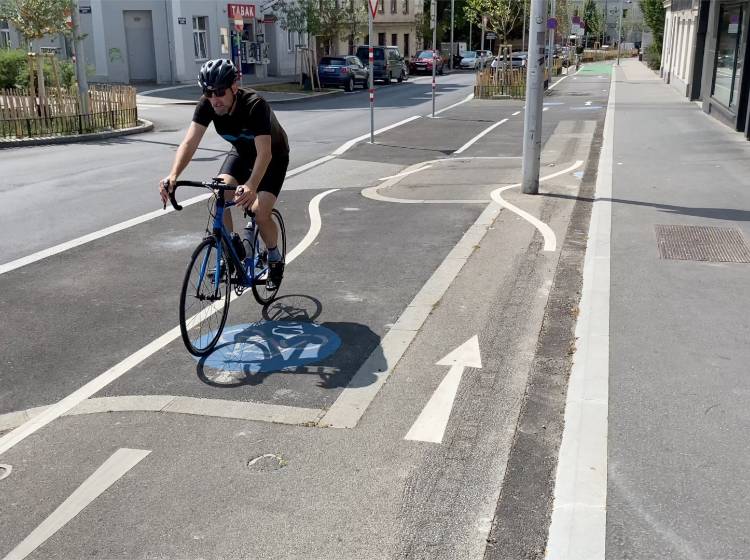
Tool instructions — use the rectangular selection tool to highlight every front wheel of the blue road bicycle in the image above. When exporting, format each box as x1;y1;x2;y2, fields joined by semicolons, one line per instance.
180;238;232;356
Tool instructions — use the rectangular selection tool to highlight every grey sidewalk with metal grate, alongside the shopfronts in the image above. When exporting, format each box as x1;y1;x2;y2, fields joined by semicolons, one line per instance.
560;59;750;560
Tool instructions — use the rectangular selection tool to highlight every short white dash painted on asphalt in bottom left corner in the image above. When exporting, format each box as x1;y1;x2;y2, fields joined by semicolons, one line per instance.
4;449;151;560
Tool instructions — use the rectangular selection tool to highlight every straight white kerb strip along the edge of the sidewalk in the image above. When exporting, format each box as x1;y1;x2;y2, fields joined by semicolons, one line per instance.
545;67;616;560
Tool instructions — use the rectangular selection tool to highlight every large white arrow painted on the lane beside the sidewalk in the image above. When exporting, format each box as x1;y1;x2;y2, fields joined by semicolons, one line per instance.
404;335;482;443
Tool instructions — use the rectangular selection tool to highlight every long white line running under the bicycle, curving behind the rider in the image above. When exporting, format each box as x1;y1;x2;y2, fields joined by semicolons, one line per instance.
0;189;338;455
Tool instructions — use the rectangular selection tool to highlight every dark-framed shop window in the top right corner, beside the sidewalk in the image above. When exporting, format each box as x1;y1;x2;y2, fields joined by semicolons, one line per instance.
711;6;743;108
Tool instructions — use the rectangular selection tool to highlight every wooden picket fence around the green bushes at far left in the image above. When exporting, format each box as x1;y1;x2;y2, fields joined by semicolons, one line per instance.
0;85;138;139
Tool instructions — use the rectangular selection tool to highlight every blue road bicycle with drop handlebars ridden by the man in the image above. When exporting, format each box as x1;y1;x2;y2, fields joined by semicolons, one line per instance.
169;178;286;356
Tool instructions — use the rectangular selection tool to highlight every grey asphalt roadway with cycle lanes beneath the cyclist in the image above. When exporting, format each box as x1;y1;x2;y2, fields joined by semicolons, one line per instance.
0;69;608;559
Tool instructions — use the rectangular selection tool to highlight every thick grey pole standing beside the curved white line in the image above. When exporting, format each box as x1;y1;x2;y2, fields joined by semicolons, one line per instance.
522;0;547;194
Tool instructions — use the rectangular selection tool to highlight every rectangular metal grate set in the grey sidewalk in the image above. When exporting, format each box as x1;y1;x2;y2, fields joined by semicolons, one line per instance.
656;225;750;263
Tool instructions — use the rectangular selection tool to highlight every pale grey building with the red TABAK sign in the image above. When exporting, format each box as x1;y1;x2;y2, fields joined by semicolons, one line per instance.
0;0;304;84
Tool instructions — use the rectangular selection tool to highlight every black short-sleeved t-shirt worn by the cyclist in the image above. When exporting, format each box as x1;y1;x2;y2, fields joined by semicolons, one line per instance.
193;89;289;161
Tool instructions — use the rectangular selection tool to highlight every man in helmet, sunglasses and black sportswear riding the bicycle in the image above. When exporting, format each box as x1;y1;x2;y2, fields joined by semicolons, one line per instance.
159;59;289;285
